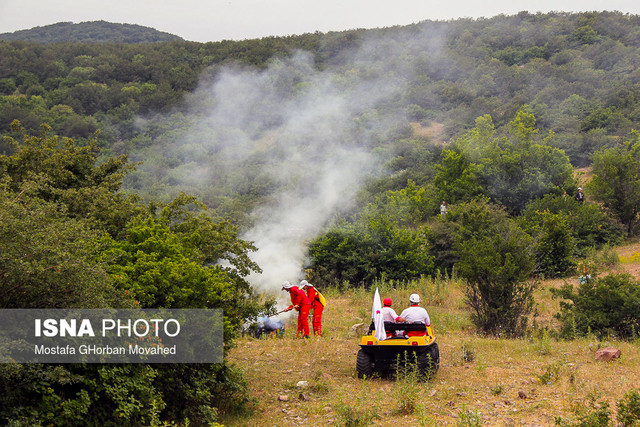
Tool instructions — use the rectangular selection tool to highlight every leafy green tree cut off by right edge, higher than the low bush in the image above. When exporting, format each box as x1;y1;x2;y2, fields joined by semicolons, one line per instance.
587;131;640;234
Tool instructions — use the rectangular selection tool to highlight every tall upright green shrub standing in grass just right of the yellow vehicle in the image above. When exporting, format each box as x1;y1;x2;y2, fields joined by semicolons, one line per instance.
446;201;535;336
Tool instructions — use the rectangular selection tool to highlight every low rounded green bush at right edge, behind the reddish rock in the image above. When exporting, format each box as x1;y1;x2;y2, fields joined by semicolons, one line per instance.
552;274;640;338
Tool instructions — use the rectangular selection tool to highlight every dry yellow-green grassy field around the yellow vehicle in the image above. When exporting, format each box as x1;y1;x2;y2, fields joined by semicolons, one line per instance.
224;252;640;426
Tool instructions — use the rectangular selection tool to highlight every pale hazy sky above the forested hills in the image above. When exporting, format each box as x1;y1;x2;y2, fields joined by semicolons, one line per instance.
0;0;640;42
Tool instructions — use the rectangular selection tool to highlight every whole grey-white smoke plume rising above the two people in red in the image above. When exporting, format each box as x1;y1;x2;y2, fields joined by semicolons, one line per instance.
134;30;438;300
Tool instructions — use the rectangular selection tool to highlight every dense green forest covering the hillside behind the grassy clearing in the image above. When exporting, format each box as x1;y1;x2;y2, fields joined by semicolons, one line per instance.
0;12;640;425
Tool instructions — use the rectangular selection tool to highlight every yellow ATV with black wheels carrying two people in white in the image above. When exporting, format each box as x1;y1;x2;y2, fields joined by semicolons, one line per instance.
356;322;440;379
